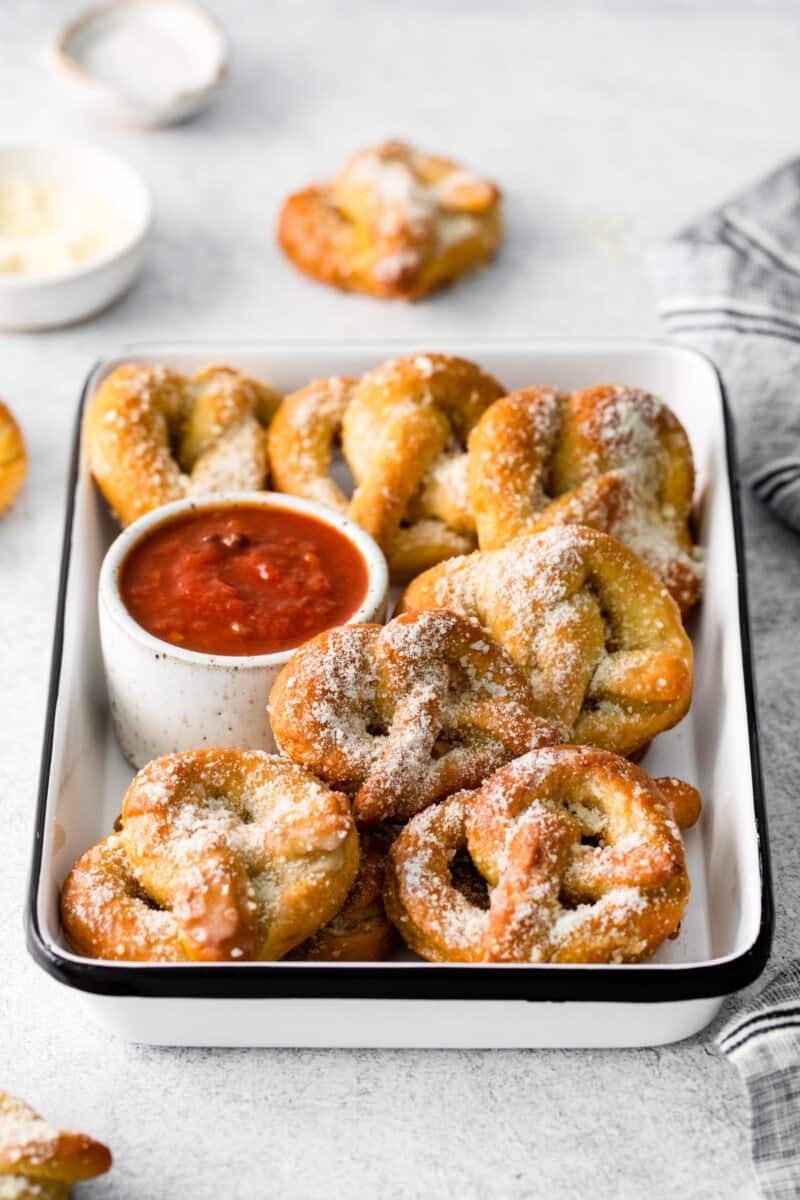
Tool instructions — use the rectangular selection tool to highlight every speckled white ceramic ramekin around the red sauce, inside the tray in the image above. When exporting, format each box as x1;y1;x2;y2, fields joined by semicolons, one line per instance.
98;492;389;768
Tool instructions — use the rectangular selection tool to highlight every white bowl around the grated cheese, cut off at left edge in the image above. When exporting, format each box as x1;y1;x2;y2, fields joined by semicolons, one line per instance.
0;144;152;330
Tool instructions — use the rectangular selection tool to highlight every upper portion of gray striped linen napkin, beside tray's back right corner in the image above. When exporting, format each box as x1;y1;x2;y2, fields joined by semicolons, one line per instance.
650;160;800;529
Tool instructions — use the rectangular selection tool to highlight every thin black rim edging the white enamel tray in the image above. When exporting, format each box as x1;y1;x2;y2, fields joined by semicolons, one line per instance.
25;340;774;1003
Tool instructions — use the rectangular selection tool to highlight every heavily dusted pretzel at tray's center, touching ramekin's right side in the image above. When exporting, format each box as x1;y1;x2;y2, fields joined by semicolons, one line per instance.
270;612;559;823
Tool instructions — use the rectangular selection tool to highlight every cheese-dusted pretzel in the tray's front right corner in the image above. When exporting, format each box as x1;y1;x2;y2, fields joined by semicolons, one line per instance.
385;746;699;962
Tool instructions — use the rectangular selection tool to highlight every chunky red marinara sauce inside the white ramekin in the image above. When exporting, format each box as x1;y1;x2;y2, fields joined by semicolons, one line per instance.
120;504;368;655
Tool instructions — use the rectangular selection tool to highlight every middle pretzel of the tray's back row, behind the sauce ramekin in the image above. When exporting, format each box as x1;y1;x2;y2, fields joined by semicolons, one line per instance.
269;354;503;580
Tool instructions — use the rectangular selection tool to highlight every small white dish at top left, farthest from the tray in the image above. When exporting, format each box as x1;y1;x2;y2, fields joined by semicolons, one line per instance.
53;0;227;128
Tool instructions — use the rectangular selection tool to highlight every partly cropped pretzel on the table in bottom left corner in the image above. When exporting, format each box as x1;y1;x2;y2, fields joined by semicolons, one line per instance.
0;1091;112;1200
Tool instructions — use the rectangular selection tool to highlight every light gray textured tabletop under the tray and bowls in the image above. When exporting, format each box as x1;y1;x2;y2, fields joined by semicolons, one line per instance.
0;0;800;1200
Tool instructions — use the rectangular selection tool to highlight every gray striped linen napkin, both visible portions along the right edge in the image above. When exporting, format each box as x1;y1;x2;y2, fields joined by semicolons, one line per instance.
649;160;800;1200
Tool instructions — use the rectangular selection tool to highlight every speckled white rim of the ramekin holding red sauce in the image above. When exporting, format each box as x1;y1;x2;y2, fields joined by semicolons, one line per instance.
98;492;389;671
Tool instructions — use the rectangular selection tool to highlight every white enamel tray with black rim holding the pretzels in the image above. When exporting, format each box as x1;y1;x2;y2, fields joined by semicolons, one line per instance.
28;342;772;1046
